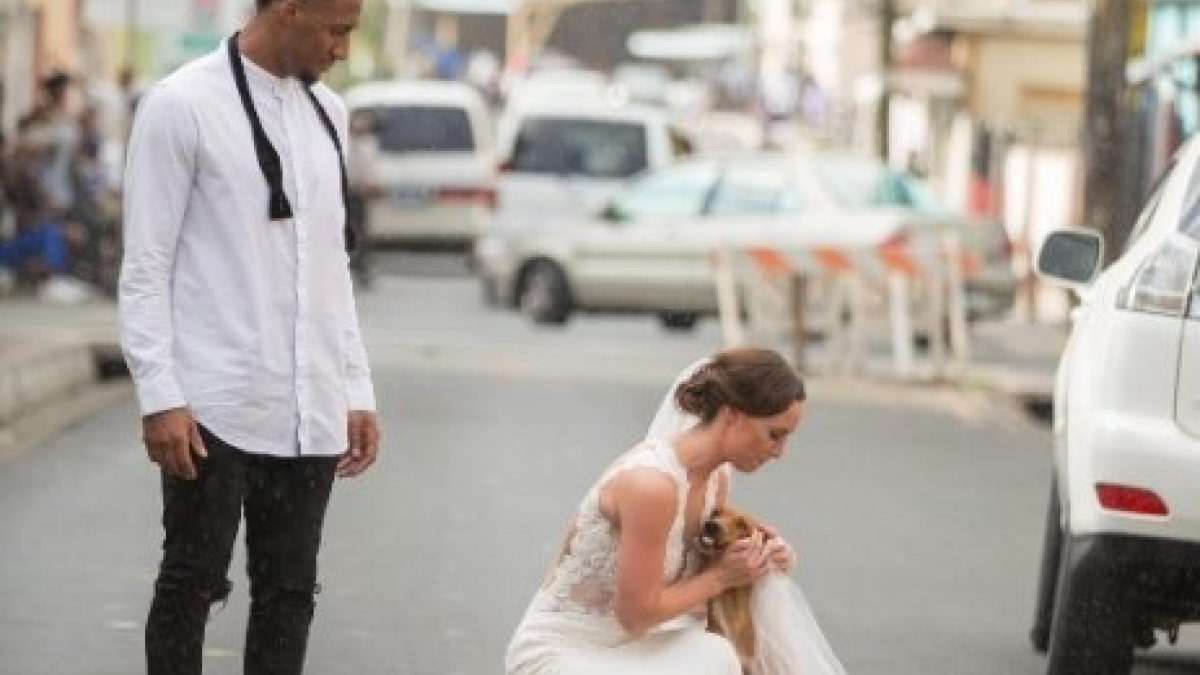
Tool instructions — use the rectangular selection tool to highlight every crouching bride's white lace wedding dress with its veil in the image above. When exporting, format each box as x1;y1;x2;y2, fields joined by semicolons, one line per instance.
504;360;846;675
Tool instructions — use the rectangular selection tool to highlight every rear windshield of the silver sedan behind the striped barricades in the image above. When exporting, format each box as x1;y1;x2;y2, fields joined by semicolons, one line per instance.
816;160;948;215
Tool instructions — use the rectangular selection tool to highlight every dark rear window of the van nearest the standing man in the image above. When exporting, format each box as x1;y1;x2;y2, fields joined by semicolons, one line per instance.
372;106;475;153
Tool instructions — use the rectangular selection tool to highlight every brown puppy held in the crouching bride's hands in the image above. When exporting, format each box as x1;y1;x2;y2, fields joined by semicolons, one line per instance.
696;507;761;665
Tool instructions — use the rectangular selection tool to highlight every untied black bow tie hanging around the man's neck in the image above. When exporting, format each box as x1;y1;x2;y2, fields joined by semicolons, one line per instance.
228;32;356;251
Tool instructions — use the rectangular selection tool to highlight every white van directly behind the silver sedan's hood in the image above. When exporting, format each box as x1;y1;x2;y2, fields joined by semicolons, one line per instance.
497;98;688;233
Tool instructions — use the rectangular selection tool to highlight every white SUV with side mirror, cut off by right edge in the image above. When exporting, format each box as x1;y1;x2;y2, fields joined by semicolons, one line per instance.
1032;133;1200;675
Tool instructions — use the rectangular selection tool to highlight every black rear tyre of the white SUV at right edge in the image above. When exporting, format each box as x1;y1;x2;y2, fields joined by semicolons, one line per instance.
1046;542;1134;675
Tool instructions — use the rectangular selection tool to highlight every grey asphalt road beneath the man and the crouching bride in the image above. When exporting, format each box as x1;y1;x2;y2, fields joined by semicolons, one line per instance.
0;253;1200;675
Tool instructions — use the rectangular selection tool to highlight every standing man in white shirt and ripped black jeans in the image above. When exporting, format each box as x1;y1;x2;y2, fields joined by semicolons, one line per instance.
120;0;379;675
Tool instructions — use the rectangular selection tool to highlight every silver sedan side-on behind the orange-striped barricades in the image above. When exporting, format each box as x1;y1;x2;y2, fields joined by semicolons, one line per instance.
475;154;1015;328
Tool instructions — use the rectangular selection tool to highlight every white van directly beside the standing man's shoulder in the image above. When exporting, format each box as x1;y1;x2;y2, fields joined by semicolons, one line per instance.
343;80;496;246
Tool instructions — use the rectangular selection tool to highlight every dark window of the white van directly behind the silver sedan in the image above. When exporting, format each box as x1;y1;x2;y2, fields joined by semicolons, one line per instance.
509;118;647;178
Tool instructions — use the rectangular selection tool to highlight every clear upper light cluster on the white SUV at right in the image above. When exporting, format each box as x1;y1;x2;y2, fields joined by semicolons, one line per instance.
1117;234;1196;316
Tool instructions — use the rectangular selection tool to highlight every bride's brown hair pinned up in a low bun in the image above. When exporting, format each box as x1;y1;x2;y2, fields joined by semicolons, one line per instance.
674;347;805;422
